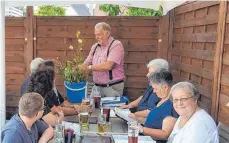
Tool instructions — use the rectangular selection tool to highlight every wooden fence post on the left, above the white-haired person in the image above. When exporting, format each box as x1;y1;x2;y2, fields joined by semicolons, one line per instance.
24;6;34;76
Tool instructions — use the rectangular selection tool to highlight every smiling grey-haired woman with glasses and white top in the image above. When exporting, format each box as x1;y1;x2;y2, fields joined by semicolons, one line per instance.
168;82;219;143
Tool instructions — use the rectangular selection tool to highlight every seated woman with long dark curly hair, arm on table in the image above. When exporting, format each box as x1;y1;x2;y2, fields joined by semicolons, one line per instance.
26;68;64;125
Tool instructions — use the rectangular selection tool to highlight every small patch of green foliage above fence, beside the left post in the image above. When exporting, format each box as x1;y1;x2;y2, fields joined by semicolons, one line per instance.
35;5;66;16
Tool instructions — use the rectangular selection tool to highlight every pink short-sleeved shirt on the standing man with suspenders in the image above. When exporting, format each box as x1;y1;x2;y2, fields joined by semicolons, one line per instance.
84;37;125;84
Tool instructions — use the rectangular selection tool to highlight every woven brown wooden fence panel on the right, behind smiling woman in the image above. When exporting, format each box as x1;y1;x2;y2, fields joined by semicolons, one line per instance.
169;1;219;113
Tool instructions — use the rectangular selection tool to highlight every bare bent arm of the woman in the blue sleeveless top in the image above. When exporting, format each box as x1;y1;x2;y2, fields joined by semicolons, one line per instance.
143;116;176;140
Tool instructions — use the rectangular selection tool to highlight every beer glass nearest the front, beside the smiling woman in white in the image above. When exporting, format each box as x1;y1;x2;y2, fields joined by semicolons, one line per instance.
127;121;139;143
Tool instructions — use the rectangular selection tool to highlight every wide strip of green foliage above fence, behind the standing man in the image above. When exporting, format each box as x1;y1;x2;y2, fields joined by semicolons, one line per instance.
99;4;163;16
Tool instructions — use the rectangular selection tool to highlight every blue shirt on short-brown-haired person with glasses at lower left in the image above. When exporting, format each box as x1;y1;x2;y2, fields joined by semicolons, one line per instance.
1;114;49;143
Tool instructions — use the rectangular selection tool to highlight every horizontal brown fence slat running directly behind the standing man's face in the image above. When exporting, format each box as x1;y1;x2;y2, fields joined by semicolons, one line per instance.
37;26;158;39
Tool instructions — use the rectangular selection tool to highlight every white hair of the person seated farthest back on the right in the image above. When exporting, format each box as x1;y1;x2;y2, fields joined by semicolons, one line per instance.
147;59;169;70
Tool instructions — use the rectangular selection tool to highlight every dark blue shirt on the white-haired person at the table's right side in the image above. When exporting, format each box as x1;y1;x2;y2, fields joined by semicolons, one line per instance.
137;86;160;111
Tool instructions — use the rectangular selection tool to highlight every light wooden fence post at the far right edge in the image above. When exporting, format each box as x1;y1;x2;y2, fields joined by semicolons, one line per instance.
211;1;227;121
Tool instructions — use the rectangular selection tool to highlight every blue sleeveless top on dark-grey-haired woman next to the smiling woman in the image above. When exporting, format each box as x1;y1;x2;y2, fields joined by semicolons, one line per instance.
144;99;179;129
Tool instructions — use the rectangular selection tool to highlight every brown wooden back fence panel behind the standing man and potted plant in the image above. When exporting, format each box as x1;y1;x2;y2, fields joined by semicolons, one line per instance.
34;17;159;99
